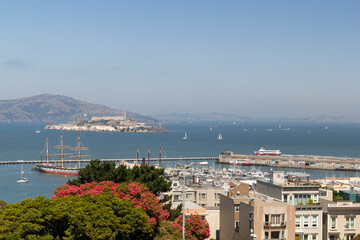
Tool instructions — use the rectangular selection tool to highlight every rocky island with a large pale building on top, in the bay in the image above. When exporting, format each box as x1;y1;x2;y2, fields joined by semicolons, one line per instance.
45;114;167;133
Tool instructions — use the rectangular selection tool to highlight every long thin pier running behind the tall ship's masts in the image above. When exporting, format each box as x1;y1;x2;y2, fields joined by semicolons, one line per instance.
0;157;219;165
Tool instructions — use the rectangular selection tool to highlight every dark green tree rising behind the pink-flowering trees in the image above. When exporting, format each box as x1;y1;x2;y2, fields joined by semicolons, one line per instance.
68;159;171;195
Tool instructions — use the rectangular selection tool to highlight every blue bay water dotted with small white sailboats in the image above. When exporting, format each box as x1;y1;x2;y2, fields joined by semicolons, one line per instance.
0;122;360;203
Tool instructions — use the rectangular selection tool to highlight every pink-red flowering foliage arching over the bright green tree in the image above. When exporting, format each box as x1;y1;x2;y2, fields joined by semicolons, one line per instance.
53;181;210;240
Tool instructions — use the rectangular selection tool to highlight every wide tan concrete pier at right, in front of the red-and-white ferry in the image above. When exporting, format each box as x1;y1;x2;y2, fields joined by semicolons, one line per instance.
218;151;360;171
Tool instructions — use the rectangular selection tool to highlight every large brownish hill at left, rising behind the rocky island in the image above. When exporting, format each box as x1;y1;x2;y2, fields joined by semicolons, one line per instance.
0;94;158;123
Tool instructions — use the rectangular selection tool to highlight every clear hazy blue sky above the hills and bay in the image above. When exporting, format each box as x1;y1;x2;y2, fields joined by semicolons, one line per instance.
0;0;360;117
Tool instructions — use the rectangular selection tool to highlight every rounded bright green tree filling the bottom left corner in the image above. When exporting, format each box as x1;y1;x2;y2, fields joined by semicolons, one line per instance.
0;194;155;240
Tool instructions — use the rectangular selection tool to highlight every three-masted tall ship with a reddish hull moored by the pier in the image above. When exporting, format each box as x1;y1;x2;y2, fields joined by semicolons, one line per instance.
34;130;90;175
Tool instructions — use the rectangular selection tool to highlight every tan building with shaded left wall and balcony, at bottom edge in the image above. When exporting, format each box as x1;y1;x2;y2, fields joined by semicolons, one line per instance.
220;184;295;240
